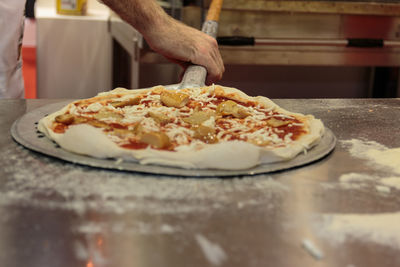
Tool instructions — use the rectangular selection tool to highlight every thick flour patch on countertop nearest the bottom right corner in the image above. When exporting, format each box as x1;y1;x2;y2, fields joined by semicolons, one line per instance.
315;212;400;249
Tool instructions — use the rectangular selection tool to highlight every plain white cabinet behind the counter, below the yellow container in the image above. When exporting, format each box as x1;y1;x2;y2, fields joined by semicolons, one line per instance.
35;0;112;98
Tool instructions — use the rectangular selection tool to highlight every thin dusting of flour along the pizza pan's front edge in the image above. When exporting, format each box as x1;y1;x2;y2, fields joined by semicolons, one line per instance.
0;146;290;216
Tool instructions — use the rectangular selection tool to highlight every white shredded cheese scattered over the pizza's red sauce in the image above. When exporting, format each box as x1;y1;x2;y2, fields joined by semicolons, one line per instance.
63;85;304;151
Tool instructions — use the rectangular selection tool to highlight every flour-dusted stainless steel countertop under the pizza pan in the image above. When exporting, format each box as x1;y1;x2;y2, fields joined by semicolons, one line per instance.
0;99;400;267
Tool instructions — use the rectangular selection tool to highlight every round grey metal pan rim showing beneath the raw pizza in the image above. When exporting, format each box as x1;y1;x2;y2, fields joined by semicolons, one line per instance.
11;101;336;177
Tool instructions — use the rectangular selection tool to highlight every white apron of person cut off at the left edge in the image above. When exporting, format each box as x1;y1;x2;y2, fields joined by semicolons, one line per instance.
0;0;25;98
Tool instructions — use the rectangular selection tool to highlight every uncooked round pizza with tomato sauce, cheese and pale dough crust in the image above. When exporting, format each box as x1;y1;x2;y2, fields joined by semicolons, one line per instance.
39;85;324;170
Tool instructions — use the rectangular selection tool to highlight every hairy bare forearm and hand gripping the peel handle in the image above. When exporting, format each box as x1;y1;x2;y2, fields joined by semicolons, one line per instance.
103;0;224;84
